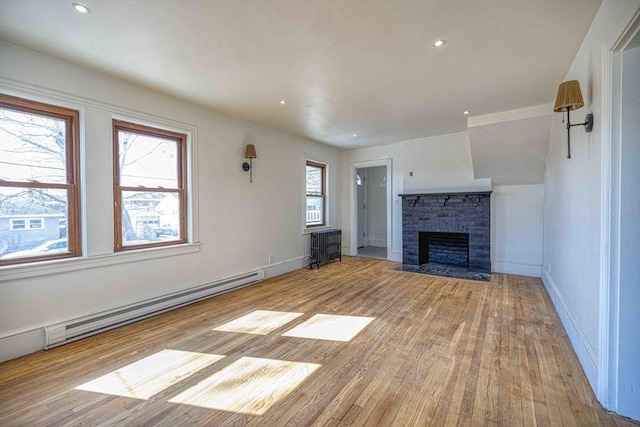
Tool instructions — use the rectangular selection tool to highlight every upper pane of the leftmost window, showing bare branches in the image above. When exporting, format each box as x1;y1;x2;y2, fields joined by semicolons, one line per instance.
0;108;67;183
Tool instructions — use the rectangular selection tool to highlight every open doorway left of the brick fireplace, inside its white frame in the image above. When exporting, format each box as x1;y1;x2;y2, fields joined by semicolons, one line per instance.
356;166;387;259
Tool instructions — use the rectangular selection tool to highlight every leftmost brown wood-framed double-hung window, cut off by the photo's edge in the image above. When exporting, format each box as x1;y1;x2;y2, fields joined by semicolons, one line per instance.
0;94;81;265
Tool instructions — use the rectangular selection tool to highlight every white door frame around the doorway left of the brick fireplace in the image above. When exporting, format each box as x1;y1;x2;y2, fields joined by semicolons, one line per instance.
349;158;393;259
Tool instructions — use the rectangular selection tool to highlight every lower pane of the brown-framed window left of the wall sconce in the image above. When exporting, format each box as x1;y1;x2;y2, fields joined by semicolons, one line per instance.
122;191;180;246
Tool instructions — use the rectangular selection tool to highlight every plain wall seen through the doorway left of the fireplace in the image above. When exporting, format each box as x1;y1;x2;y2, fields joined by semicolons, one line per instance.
366;166;387;247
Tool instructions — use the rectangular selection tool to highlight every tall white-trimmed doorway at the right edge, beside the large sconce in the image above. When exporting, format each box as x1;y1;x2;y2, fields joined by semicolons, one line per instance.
605;19;640;419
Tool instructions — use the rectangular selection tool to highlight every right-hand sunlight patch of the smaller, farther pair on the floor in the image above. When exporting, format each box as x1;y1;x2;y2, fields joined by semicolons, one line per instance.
282;314;375;342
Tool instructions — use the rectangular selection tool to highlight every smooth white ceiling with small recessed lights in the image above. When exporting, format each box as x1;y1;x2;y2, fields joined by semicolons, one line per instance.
0;0;601;148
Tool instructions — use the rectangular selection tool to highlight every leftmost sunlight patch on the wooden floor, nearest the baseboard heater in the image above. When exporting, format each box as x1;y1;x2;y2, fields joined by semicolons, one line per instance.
76;350;225;399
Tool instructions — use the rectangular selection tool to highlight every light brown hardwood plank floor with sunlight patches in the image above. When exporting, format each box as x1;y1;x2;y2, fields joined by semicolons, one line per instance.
0;257;637;426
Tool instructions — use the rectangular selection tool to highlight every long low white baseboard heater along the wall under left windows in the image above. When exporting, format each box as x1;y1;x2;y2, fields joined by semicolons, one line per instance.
44;270;265;350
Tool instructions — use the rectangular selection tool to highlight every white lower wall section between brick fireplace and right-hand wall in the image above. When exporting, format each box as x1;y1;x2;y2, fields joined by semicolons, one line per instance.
491;184;544;277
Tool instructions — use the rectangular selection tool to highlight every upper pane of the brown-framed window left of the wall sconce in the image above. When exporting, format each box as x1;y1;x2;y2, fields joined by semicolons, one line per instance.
118;131;178;188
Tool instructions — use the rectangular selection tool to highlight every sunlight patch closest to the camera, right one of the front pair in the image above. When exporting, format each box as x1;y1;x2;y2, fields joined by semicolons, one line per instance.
169;357;321;415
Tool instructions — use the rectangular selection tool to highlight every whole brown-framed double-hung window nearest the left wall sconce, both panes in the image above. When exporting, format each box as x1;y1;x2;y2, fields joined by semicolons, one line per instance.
113;120;187;250
